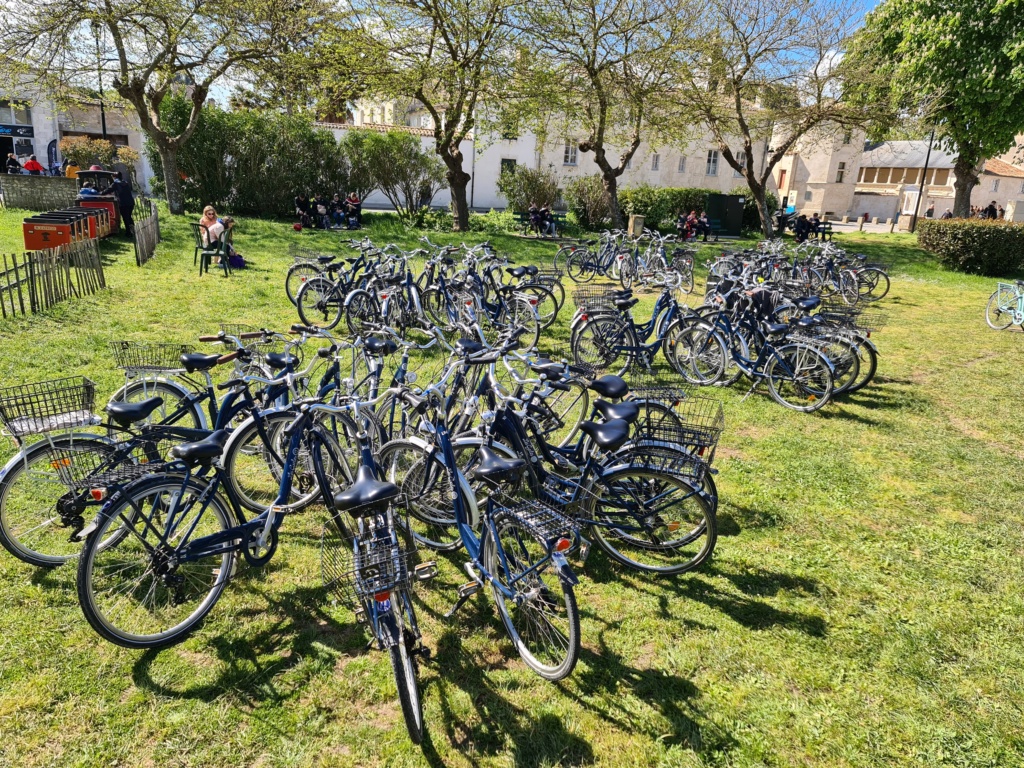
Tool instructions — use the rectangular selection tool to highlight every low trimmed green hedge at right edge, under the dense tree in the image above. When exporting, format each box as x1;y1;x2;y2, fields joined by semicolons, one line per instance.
918;219;1024;278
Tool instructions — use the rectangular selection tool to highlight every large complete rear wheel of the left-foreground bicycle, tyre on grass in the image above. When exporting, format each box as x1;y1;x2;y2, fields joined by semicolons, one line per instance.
78;477;234;648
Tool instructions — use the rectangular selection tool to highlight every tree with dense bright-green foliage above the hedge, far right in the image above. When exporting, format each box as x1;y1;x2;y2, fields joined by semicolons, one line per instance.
849;0;1024;217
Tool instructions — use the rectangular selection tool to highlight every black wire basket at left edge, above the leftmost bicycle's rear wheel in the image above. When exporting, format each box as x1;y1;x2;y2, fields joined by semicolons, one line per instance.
0;376;99;437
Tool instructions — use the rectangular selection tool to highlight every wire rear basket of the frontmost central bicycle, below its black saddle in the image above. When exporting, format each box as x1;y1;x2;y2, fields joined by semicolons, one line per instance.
321;520;416;610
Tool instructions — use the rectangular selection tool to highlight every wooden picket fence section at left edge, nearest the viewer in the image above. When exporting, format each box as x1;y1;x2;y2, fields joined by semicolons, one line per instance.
0;240;106;318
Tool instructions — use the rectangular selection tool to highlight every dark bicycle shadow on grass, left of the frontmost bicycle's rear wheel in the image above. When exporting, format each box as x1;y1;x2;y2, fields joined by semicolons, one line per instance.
132;587;367;706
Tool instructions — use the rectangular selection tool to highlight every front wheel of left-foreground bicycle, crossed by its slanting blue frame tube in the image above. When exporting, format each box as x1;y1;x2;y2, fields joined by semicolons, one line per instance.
221;412;319;512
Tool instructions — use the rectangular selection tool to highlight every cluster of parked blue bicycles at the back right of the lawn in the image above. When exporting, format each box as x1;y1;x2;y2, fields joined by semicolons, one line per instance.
569;241;889;412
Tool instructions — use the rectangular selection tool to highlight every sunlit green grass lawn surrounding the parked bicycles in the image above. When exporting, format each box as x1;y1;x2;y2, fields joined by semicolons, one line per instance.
0;211;1024;768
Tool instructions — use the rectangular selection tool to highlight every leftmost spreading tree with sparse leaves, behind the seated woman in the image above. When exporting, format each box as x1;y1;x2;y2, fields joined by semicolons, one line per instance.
0;0;334;213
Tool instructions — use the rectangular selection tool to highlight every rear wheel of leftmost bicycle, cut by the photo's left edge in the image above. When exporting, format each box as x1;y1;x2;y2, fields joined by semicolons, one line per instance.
0;435;115;568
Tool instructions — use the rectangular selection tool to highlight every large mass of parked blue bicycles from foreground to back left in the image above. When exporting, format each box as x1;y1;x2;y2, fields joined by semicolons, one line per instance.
0;236;724;741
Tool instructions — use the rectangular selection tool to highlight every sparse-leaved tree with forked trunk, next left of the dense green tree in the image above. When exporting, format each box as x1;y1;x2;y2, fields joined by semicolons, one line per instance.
679;0;877;238
